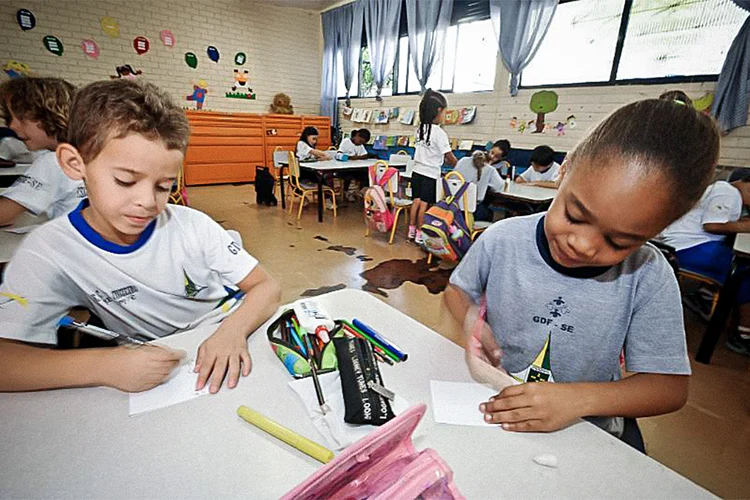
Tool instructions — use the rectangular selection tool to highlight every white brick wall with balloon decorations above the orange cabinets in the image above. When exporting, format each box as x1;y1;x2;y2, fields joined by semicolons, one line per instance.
0;0;322;114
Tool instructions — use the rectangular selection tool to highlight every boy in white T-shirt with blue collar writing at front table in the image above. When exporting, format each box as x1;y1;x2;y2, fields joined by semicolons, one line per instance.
0;79;280;393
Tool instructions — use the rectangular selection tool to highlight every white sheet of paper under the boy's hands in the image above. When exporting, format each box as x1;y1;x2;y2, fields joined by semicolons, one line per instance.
129;360;208;417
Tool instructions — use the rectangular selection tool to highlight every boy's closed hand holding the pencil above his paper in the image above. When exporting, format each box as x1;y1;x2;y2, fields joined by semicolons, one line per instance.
103;345;185;392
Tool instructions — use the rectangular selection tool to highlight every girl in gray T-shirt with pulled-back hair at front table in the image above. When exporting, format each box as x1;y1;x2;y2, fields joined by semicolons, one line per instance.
444;99;719;450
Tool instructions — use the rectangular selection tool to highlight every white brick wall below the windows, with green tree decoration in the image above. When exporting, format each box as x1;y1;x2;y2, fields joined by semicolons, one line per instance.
339;55;750;166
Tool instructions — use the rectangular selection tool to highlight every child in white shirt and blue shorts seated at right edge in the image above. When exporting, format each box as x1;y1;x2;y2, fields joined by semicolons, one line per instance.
659;174;750;356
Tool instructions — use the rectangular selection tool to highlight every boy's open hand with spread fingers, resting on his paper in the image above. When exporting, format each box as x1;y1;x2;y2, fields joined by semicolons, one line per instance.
194;322;251;394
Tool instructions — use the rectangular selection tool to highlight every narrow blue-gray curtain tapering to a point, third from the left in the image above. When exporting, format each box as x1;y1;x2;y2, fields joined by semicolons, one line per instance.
358;0;401;100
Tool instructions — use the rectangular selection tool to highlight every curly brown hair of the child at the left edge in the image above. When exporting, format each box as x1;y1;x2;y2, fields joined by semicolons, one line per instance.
0;77;76;142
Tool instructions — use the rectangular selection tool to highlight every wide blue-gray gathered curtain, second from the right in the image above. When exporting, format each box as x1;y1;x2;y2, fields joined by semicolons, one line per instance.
490;0;558;95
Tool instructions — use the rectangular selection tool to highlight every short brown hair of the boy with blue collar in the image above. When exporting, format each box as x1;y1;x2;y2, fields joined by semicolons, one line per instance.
68;79;190;162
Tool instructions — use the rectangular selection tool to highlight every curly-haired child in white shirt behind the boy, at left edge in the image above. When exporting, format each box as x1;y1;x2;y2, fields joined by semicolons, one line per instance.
0;77;86;225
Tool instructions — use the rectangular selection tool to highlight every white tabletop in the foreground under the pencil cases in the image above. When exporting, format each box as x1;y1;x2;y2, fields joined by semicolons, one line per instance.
0;290;711;499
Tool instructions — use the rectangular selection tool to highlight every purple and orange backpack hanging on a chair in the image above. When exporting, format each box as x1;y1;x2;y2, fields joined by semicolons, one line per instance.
421;179;473;262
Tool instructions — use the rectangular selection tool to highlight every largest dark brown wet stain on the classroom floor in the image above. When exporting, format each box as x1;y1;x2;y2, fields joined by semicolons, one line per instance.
359;258;453;297
